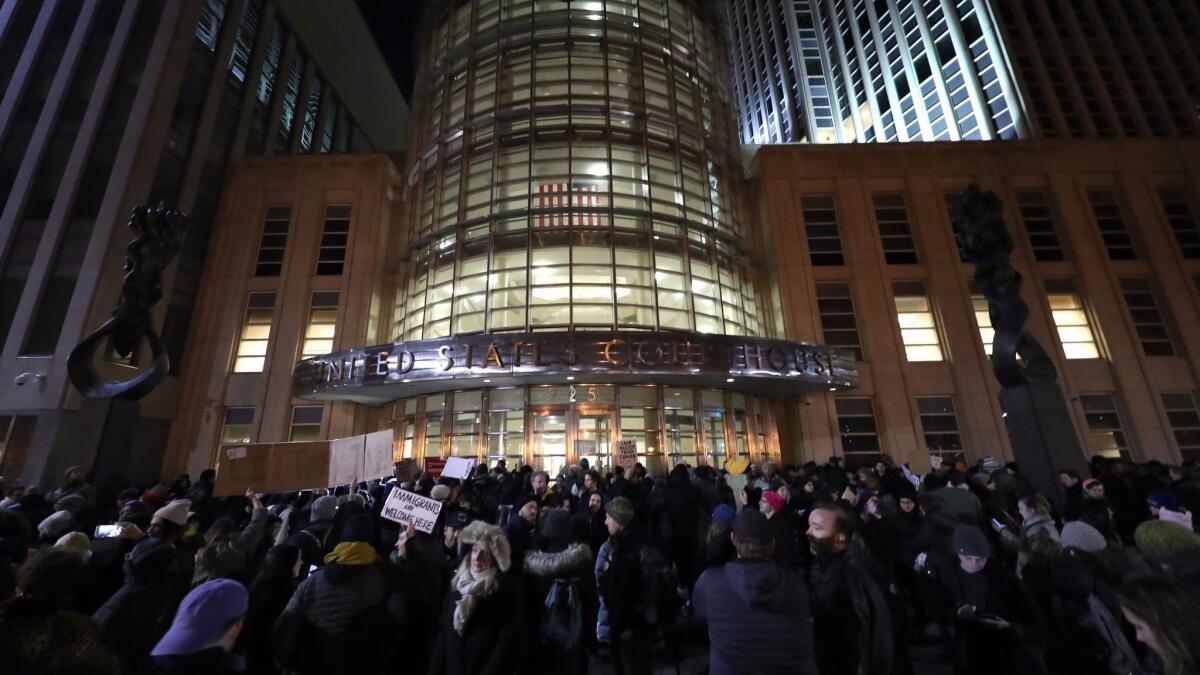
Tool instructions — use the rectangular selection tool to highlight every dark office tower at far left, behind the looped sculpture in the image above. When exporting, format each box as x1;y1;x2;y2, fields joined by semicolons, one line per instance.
0;0;407;483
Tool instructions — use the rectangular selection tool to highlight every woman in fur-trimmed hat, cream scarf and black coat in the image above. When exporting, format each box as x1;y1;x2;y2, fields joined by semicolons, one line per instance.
430;521;524;675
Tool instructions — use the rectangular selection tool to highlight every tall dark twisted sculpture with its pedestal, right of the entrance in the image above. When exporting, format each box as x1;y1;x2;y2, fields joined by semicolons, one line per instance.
950;185;1084;497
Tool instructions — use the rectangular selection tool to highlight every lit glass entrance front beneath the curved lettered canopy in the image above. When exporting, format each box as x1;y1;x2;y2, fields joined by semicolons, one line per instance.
383;383;779;476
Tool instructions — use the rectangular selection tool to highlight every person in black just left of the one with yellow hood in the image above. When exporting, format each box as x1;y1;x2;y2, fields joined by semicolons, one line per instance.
234;544;301;675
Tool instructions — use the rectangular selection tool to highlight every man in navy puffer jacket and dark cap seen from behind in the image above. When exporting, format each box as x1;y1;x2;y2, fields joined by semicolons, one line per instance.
692;510;817;675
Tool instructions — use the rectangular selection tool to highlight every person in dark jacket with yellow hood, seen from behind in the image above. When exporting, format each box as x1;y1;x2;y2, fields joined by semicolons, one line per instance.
272;515;389;673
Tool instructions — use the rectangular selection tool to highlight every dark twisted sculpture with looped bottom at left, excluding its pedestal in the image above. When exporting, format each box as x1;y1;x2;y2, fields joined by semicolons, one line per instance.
67;203;188;401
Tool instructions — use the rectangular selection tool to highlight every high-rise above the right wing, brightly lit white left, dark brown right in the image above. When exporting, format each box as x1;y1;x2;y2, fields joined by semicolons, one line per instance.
725;0;1200;144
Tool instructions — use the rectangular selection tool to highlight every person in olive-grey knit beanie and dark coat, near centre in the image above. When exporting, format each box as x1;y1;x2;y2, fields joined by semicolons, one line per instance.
595;497;650;673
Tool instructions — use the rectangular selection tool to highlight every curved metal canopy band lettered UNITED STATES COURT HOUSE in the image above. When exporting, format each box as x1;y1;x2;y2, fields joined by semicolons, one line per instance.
293;331;857;402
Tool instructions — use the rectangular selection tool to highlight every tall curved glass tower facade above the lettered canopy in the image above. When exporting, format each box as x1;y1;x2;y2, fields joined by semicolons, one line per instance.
394;0;763;340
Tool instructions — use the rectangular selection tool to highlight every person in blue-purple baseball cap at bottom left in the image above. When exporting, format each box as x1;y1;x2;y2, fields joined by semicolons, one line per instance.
150;579;250;675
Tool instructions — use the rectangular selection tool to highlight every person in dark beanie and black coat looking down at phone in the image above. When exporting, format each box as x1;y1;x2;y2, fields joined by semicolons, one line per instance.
940;525;1046;675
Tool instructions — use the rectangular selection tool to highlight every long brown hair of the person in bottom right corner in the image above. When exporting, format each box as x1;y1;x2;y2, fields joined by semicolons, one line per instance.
1118;577;1200;675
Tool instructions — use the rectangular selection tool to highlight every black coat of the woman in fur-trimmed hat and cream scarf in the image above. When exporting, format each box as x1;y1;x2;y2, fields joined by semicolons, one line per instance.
430;573;524;675
